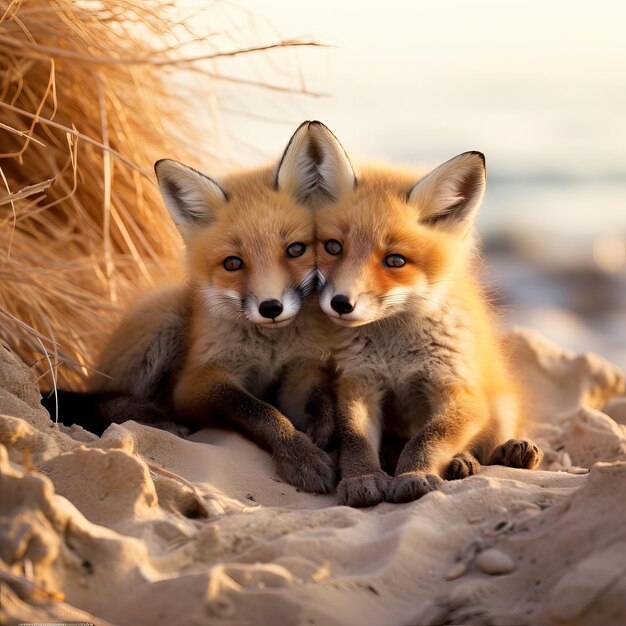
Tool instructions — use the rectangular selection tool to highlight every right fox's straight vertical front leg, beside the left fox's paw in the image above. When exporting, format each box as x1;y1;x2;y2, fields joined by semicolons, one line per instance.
337;381;391;507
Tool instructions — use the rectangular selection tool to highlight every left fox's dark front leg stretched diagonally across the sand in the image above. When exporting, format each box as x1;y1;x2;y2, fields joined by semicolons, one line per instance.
174;366;335;493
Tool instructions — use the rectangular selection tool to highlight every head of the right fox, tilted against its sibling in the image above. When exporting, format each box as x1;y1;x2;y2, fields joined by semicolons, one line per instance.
315;135;485;326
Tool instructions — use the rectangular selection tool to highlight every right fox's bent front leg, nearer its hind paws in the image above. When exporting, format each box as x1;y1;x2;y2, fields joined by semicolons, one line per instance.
388;388;488;502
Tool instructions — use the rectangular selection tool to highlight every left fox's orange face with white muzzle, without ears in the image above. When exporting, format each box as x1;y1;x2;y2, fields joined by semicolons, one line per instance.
188;189;315;328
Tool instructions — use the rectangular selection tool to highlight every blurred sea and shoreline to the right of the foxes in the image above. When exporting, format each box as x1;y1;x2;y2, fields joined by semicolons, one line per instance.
479;177;626;370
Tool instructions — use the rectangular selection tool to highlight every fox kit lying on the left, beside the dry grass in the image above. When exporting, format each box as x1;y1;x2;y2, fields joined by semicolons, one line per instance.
49;122;348;492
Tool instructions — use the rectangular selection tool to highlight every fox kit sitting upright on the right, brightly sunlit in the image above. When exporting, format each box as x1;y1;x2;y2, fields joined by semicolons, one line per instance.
316;132;542;506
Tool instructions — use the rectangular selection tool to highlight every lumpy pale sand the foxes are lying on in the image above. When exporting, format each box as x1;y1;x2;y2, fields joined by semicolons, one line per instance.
0;330;626;626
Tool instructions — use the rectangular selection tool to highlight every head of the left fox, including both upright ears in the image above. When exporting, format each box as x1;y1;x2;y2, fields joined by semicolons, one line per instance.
155;122;343;328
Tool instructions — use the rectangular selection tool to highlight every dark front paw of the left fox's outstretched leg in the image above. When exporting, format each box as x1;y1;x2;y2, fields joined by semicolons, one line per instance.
272;432;337;493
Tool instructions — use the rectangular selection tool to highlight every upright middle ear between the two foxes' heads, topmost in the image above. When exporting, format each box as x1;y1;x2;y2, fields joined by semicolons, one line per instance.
276;122;356;208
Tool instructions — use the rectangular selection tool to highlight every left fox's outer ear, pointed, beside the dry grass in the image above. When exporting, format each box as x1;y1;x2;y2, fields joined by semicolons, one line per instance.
154;159;228;232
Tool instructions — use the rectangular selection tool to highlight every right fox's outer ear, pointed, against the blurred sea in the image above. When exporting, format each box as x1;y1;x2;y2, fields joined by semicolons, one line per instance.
408;152;486;234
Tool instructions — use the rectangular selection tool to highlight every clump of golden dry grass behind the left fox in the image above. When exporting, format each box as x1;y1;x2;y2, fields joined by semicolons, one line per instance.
0;0;320;387
